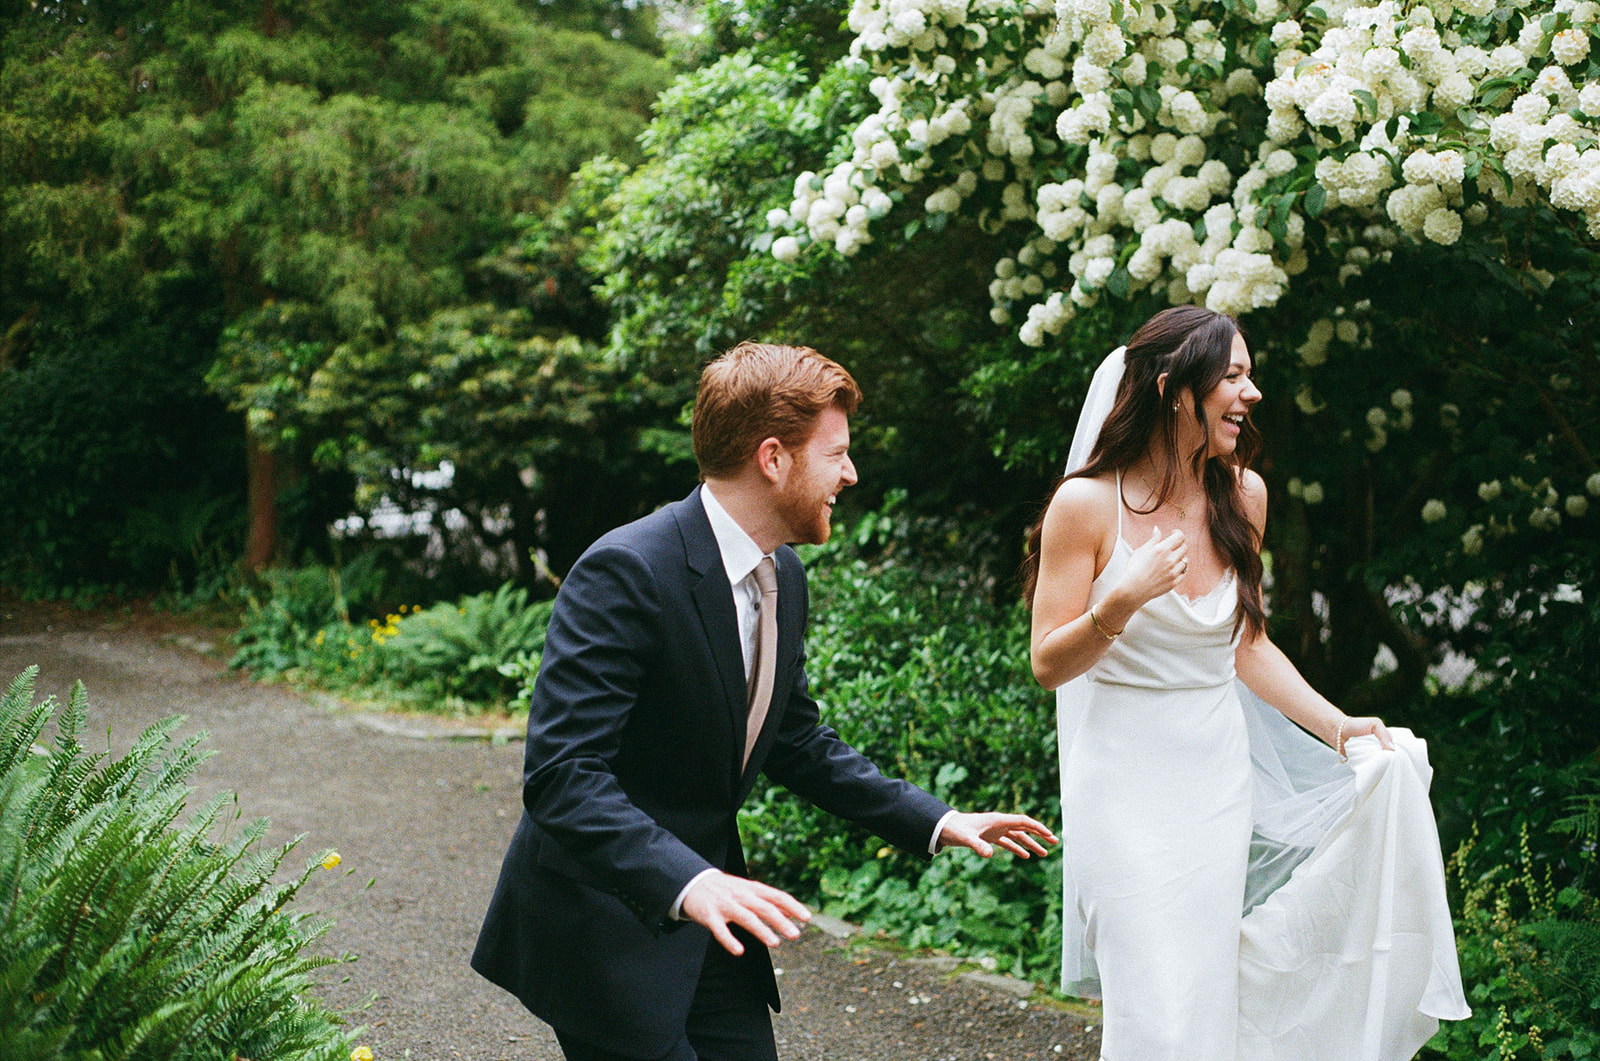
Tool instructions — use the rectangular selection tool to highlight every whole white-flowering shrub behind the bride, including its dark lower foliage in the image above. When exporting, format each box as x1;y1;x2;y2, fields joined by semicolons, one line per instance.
742;0;1600;672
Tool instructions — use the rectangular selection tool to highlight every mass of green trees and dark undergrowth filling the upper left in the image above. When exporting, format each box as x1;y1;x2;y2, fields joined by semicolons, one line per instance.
0;0;666;591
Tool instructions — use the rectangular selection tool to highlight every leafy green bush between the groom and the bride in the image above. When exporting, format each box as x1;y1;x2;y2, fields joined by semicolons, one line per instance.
741;498;1061;979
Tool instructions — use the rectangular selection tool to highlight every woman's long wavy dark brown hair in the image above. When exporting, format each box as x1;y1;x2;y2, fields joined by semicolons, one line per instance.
1022;306;1267;637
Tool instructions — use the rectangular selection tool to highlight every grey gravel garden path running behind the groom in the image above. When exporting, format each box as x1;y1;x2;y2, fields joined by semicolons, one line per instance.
0;599;1099;1061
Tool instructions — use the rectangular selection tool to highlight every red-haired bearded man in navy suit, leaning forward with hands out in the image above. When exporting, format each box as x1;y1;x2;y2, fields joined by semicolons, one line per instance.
472;342;1054;1061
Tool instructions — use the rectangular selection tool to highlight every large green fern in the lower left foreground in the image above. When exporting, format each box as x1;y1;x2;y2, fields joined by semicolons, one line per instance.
0;669;350;1061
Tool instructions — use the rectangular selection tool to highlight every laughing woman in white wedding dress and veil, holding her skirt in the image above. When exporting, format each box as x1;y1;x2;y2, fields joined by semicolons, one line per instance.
1026;306;1467;1061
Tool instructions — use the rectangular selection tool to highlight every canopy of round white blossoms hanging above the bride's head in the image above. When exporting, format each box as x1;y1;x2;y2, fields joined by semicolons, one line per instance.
770;0;1600;352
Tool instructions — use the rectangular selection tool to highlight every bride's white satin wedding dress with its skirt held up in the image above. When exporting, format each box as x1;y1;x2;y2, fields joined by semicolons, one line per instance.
1059;490;1469;1061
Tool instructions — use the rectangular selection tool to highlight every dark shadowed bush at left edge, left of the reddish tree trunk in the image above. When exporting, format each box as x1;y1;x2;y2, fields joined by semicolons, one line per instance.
0;318;243;592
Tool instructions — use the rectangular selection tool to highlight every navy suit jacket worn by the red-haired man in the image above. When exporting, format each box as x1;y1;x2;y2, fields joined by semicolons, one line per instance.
472;488;949;1056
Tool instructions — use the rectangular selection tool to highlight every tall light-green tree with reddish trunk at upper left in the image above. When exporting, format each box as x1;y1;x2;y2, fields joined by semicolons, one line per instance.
0;0;664;582
